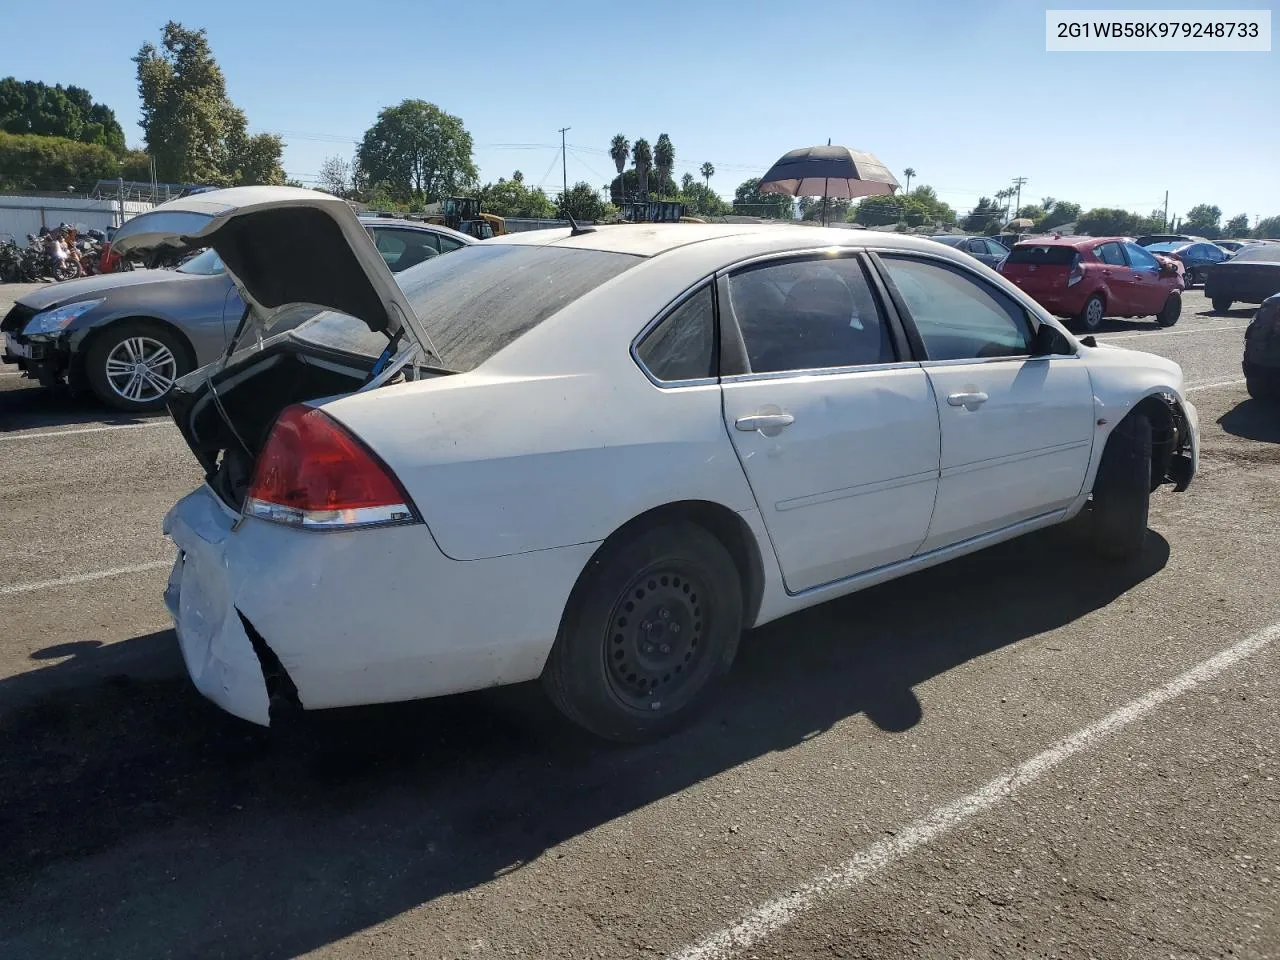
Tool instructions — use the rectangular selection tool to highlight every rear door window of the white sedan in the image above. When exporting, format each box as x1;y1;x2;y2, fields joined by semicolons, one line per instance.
728;257;897;374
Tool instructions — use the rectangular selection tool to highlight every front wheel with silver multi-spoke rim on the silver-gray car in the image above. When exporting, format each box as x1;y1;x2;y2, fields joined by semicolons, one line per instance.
84;320;191;411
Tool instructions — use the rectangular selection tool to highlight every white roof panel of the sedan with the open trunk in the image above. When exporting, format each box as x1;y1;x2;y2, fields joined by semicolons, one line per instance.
480;221;972;257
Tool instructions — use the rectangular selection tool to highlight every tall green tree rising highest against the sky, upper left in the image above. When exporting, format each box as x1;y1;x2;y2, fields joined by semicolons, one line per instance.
133;20;284;184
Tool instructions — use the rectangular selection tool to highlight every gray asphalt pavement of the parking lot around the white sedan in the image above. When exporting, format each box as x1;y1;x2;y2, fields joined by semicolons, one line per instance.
0;285;1280;960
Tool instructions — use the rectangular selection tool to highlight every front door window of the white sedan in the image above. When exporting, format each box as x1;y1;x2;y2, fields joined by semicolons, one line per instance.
881;253;1032;360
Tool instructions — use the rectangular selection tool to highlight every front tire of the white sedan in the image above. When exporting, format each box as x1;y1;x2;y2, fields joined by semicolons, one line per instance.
1088;413;1151;561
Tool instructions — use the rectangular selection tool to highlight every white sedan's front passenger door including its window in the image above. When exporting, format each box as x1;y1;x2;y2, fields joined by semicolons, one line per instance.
881;253;1093;552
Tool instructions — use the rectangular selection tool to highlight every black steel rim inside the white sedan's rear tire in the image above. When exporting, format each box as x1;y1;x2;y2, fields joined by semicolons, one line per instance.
604;561;708;709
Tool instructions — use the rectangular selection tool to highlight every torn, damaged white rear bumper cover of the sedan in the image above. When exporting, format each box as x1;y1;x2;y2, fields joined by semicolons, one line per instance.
165;486;595;724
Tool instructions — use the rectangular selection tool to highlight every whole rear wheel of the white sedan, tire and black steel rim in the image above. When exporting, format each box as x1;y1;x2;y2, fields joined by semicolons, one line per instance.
543;522;742;742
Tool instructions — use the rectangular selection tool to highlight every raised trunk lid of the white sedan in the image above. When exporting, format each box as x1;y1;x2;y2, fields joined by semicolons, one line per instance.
111;187;435;358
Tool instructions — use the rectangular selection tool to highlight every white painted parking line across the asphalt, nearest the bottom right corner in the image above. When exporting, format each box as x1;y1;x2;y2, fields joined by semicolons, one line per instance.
672;623;1280;960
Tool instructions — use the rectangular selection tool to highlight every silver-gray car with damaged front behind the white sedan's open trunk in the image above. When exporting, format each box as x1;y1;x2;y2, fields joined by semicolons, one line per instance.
0;214;476;411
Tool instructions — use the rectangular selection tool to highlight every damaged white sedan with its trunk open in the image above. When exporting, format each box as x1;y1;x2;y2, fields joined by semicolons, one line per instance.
115;187;1198;740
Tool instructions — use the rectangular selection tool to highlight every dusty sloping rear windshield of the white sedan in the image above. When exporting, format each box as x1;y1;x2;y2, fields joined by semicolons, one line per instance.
397;243;643;371
